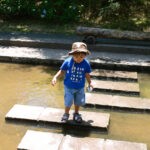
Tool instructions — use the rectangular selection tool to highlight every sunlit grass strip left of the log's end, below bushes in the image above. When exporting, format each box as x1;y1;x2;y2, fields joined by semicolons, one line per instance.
0;20;77;34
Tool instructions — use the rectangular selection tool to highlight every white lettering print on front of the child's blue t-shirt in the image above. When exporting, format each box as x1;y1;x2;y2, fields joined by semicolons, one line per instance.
70;64;84;83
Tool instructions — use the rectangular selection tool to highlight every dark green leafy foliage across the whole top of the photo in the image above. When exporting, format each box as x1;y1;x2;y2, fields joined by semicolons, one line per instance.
0;0;150;30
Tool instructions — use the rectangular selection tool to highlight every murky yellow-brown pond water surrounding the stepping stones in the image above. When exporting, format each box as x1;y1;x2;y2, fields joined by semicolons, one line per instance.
0;63;150;150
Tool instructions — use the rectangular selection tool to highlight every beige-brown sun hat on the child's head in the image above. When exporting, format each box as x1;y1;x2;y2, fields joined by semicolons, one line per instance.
68;42;90;55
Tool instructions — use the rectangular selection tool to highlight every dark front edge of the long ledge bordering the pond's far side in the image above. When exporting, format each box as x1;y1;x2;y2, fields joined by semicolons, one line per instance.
0;56;150;72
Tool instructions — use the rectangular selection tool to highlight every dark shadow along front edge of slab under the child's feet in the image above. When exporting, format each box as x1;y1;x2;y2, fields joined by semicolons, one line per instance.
5;118;107;136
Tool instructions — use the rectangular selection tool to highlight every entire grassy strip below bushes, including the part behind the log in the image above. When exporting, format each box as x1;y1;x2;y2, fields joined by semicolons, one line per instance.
0;19;150;34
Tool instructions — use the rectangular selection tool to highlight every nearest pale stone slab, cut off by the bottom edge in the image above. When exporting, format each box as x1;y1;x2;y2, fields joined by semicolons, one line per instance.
18;130;147;150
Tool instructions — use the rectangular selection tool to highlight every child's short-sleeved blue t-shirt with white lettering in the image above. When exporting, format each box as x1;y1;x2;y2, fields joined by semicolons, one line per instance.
60;57;91;89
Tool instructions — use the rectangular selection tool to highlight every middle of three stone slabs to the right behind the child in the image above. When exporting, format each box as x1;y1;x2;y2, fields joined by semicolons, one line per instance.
92;79;140;95
